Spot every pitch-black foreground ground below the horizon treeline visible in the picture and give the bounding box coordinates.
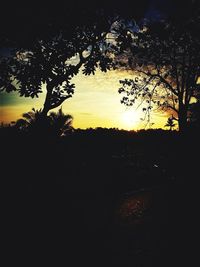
[1,129,199,267]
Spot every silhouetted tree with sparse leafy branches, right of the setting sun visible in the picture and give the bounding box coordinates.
[118,12,200,132]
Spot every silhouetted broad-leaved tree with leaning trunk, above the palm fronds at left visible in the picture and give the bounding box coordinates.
[0,17,112,116]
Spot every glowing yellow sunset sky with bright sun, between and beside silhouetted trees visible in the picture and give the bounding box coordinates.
[0,68,167,130]
